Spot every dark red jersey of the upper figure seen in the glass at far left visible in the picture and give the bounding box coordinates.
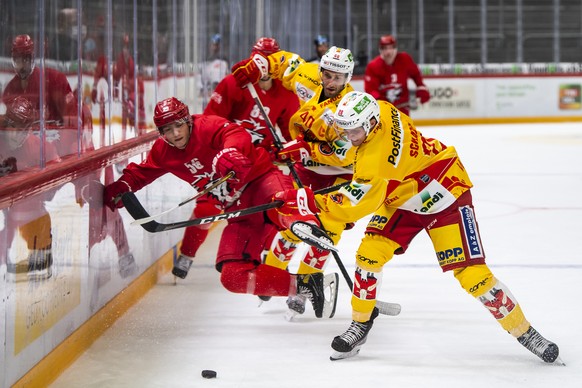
[2,67,77,122]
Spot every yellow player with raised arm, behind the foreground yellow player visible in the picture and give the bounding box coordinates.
[233,46,355,318]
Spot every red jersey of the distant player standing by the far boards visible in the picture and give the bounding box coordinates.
[364,52,424,110]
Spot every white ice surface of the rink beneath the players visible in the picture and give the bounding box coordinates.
[52,123,582,388]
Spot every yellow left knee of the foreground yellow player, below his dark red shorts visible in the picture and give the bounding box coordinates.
[356,234,400,272]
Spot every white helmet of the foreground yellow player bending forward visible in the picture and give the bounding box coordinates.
[334,91,380,136]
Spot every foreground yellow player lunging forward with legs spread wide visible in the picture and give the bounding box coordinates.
[282,92,559,363]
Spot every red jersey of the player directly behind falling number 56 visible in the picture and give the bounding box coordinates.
[204,74,299,152]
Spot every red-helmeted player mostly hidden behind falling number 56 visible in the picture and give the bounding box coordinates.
[172,38,299,279]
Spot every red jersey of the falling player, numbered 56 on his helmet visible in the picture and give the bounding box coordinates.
[119,115,276,201]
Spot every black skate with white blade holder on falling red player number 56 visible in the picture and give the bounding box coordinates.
[296,273,339,318]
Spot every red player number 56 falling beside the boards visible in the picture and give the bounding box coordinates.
[103,97,338,318]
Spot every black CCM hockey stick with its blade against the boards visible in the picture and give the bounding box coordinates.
[121,183,345,233]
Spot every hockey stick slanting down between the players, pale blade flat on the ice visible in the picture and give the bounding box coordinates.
[247,82,401,315]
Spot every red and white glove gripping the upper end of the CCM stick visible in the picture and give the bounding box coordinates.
[267,187,319,229]
